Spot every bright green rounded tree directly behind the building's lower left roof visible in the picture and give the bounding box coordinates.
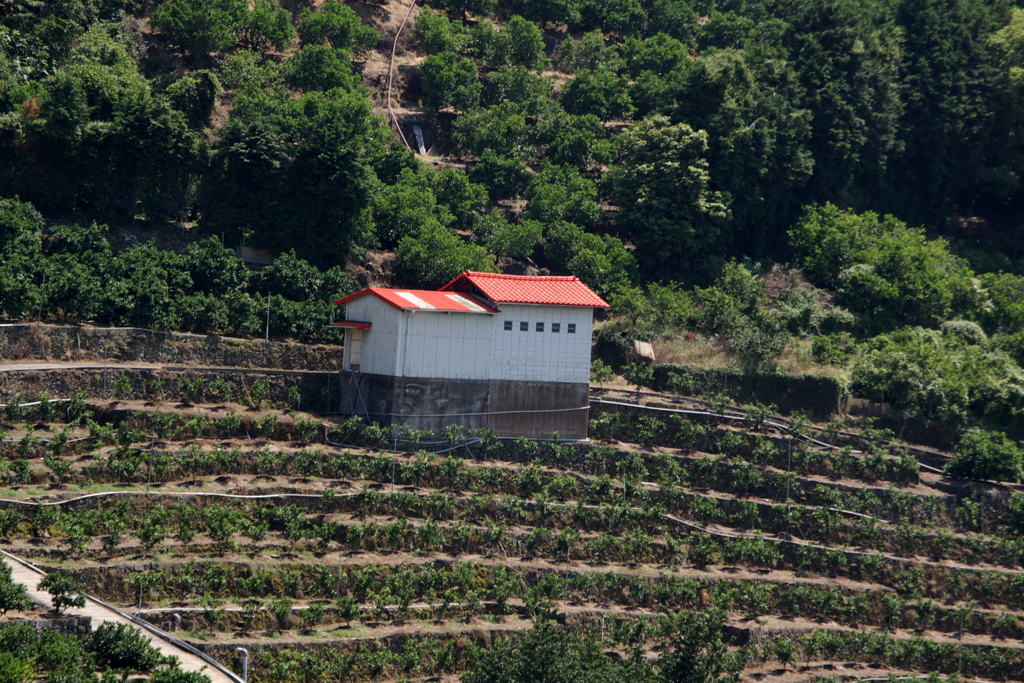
[396,222,497,289]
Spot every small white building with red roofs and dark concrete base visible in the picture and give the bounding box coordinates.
[335,271,608,439]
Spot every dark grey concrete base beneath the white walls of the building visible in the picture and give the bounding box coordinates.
[340,371,590,439]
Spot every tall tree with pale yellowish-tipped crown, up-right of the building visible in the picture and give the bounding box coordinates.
[608,117,728,282]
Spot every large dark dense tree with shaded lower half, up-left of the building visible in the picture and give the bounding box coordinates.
[201,89,378,264]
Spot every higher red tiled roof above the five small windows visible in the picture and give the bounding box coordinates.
[441,270,608,308]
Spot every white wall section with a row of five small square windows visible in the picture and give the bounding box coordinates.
[490,303,594,383]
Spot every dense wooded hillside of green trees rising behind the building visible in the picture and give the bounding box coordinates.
[6,0,1024,444]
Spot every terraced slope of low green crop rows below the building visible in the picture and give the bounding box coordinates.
[0,385,1024,683]
